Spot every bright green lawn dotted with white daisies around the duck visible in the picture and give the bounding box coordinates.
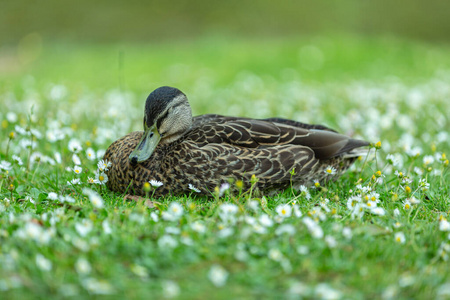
[0,37,450,299]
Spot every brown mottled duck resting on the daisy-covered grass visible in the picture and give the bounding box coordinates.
[104,86,369,197]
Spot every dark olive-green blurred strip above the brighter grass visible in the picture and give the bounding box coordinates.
[0,0,450,44]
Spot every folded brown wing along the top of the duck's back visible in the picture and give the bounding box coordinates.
[188,115,369,159]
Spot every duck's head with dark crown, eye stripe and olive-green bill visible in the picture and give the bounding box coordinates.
[129,86,192,165]
